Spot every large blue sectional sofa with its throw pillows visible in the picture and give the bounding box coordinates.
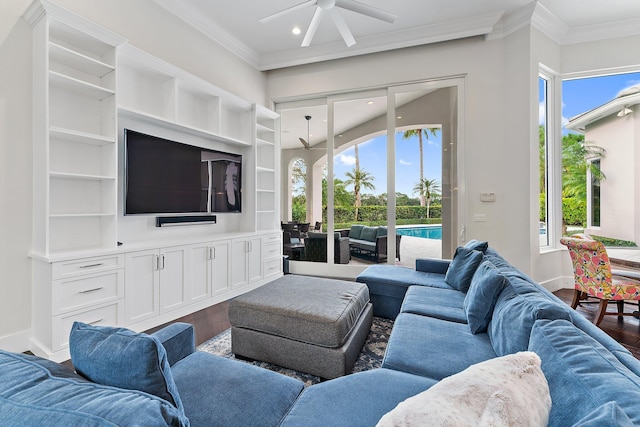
[0,241,640,427]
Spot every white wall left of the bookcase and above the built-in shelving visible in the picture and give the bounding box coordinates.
[0,0,267,351]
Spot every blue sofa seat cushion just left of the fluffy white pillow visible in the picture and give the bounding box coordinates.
[280,368,436,427]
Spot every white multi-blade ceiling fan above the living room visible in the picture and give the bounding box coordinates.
[260,0,397,47]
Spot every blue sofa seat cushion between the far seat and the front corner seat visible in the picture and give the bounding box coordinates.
[382,313,496,380]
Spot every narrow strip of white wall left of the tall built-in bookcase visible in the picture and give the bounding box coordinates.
[0,15,32,350]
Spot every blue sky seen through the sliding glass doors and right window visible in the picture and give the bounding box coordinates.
[334,73,640,201]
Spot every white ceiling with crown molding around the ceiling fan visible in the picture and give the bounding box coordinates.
[155,0,640,70]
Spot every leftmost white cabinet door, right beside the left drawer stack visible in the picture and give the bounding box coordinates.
[124,250,160,324]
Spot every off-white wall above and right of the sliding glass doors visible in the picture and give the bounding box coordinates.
[268,30,537,271]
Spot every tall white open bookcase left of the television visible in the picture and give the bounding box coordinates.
[25,2,124,256]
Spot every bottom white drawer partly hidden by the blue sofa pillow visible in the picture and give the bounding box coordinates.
[52,301,124,351]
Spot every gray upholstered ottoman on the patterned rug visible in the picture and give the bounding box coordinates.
[229,275,373,379]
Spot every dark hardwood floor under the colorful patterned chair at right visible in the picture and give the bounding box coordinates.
[554,289,640,359]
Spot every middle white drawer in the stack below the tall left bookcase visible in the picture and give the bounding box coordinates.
[51,269,124,316]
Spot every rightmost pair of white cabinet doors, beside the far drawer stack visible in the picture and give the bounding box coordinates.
[231,236,262,289]
